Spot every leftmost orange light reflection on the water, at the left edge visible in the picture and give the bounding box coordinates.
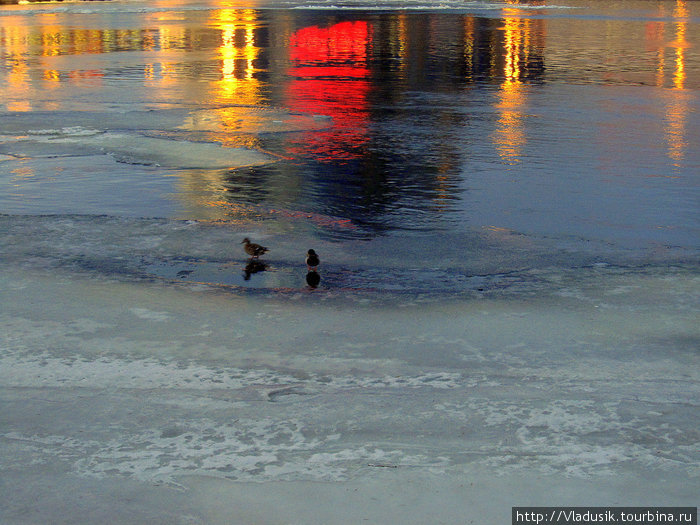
[0,21,32,111]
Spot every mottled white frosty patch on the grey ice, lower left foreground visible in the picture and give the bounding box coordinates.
[0,424,448,483]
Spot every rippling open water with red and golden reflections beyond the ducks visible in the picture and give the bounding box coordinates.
[0,0,700,286]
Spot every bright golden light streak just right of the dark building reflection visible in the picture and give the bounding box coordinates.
[493,18,529,164]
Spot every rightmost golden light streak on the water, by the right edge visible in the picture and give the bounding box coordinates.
[666,0,688,168]
